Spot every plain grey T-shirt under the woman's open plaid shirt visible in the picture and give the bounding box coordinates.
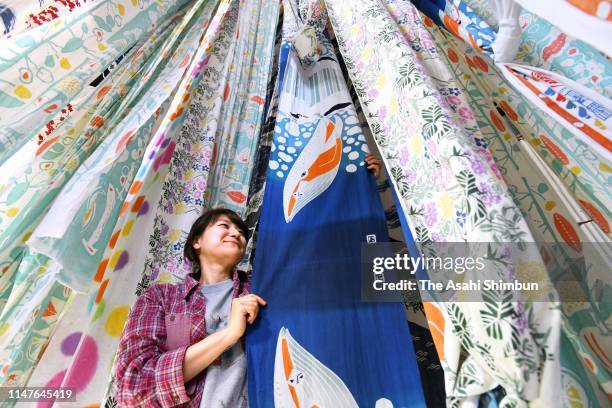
[200,279,249,408]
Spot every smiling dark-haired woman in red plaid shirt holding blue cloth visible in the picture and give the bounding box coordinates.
[116,209,266,407]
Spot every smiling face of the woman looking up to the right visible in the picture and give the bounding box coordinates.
[193,215,246,265]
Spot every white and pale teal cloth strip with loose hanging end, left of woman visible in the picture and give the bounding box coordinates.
[3,7,208,388]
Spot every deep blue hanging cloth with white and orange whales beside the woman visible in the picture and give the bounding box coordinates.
[246,2,425,407]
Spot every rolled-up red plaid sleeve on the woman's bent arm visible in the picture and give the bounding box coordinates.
[115,285,190,407]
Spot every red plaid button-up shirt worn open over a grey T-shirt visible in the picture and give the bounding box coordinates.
[115,271,250,408]
